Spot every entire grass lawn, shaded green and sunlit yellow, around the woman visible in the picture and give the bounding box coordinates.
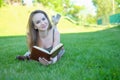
[0,7,120,80]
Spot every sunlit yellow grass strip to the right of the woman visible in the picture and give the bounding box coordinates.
[58,17,111,33]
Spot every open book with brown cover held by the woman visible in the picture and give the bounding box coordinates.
[30,43,63,61]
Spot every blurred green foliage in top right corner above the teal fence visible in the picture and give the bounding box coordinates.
[93,0,120,17]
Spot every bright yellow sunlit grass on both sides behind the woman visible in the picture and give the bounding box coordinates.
[0,5,114,36]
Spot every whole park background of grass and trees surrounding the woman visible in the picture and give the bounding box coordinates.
[0,0,120,80]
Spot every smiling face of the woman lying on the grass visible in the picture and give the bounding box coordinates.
[32,13,49,31]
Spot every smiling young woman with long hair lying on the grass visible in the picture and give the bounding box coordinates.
[16,10,64,65]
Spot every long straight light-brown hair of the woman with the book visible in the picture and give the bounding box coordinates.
[27,10,52,51]
